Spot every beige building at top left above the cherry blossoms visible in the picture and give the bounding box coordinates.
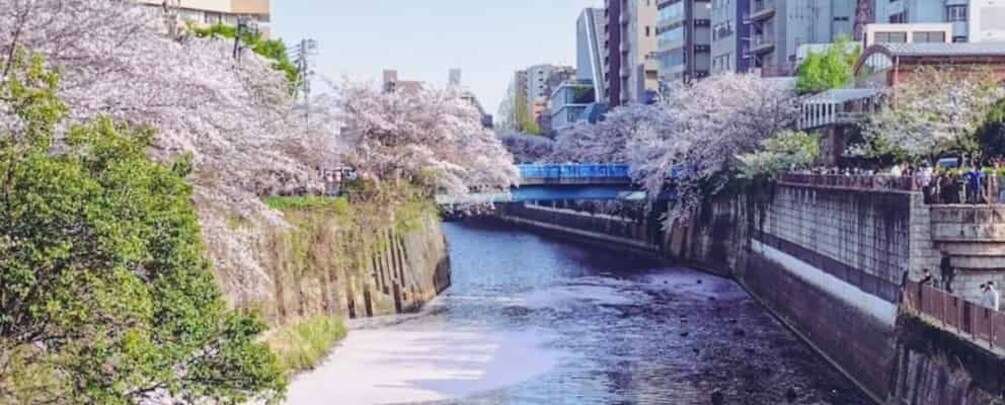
[137,0,270,37]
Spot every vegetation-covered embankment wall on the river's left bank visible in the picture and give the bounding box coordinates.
[239,207,450,325]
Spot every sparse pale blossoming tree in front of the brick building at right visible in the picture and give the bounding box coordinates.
[849,67,1005,160]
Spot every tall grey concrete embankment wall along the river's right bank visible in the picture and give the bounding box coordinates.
[492,185,956,402]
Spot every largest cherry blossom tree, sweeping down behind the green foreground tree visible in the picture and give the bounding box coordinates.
[0,0,333,298]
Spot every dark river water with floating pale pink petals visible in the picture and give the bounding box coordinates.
[287,223,869,405]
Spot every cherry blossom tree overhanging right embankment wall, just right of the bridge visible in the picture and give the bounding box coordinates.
[627,74,798,219]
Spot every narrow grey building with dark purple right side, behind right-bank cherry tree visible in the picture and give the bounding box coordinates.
[709,0,750,74]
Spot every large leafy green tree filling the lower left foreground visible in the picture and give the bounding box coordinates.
[0,51,286,404]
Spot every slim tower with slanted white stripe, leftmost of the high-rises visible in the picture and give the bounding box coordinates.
[576,8,606,97]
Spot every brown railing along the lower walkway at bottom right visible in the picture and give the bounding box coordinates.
[903,281,1005,352]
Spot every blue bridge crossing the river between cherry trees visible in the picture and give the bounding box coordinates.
[436,164,646,205]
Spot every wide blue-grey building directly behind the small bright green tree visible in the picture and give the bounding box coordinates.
[746,0,856,75]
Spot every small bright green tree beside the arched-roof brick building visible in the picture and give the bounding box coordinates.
[796,36,861,94]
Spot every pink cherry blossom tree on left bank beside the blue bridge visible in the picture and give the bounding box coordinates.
[337,82,519,195]
